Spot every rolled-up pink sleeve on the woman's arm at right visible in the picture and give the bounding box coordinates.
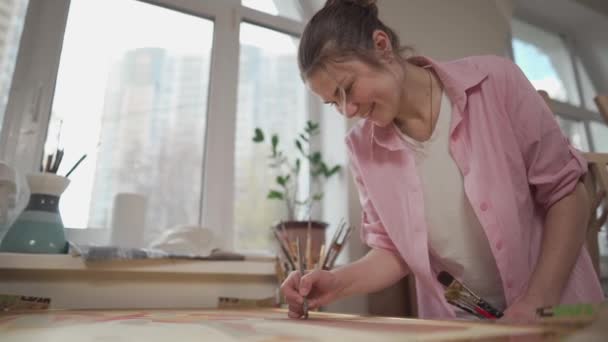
[505,61,587,210]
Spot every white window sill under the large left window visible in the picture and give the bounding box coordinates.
[0,253,275,276]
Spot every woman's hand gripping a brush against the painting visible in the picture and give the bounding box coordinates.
[281,270,342,318]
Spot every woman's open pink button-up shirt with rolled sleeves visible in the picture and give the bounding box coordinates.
[346,56,603,318]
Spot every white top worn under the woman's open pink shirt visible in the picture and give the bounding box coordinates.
[395,93,505,317]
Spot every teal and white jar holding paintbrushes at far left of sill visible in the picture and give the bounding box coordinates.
[0,173,70,254]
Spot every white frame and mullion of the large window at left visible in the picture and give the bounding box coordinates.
[0,0,320,249]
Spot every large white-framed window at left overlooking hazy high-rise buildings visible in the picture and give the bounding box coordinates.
[0,0,328,250]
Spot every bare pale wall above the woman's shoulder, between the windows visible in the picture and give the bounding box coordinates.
[378,0,512,60]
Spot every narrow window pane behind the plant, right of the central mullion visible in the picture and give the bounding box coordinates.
[234,23,307,250]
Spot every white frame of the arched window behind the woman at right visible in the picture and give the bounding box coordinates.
[510,14,605,152]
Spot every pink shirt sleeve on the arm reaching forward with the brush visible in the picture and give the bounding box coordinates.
[346,139,398,253]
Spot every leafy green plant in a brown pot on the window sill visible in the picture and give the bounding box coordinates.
[253,120,341,266]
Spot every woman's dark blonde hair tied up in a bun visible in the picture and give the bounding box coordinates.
[298,0,411,79]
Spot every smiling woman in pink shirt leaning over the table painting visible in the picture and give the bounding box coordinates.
[281,0,602,321]
